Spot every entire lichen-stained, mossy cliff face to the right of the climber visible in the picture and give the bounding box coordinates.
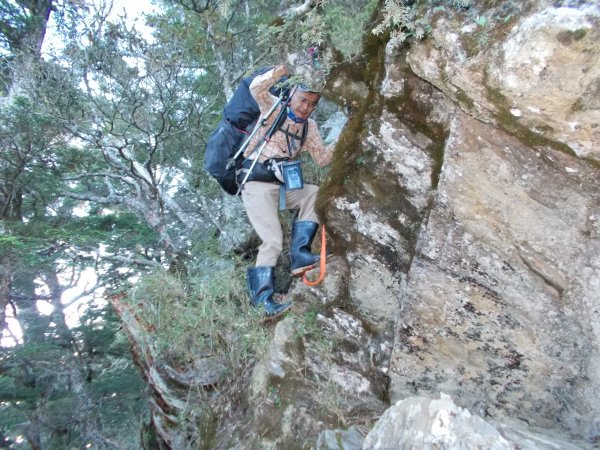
[243,1,600,449]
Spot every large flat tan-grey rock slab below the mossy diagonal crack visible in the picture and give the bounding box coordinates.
[391,115,600,437]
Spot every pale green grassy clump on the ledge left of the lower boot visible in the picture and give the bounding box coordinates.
[131,266,266,372]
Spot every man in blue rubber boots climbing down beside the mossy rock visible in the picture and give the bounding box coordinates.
[238,65,335,318]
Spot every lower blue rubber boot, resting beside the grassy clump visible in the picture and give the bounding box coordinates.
[247,266,292,319]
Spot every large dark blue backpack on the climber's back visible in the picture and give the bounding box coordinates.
[204,67,305,195]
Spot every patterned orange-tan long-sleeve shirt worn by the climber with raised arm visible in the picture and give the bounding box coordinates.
[244,66,335,167]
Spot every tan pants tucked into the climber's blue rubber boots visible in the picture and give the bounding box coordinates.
[242,181,319,267]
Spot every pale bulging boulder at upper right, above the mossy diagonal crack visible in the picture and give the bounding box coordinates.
[408,1,600,161]
